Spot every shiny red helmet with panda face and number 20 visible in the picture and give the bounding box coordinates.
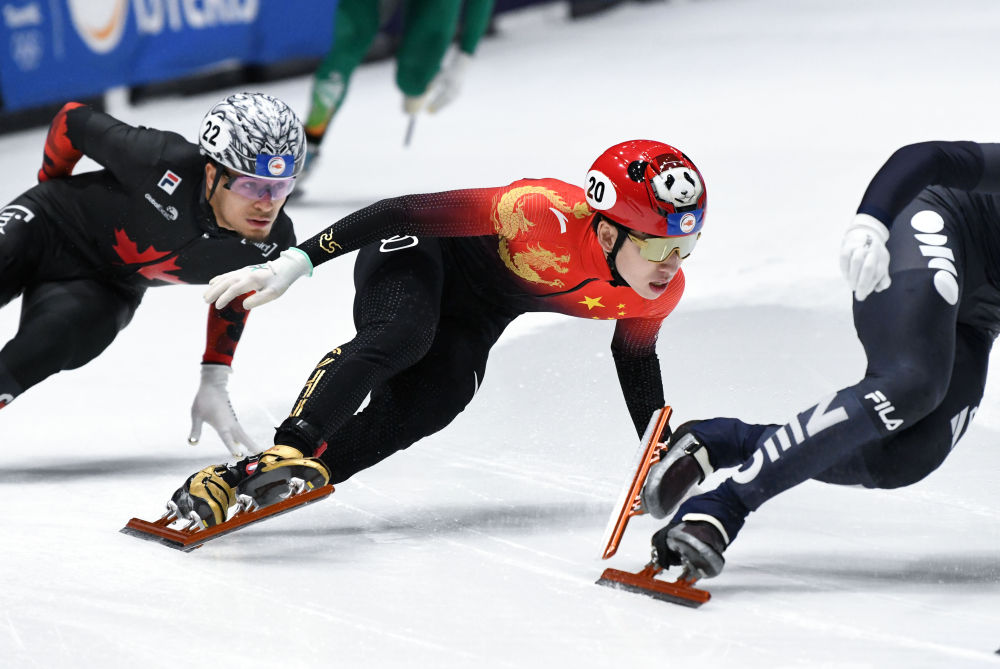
[586,139,708,237]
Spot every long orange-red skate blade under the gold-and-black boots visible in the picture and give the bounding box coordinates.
[121,485,333,553]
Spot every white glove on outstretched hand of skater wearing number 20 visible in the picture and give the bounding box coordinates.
[205,246,312,309]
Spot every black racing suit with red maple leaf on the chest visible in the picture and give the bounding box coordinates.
[0,104,295,406]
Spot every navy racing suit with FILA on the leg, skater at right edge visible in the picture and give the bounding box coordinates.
[700,142,1000,516]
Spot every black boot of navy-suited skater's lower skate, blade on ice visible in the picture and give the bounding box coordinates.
[653,481,750,578]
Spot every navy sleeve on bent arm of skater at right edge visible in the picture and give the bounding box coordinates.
[858,141,1000,227]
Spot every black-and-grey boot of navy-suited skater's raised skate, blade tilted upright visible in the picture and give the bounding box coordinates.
[642,421,715,518]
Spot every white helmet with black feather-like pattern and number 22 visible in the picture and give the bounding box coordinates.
[198,93,306,179]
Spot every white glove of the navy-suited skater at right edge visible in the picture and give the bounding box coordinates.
[840,214,891,302]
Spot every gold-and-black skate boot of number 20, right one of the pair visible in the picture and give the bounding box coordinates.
[236,445,330,508]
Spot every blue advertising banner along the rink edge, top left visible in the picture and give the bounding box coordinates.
[0,0,337,111]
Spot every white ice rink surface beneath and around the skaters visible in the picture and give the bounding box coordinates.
[0,0,1000,669]
